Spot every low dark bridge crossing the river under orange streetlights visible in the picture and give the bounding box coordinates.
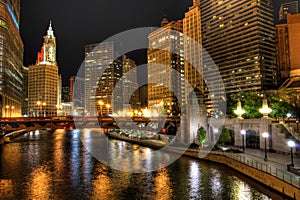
[0,116,180,135]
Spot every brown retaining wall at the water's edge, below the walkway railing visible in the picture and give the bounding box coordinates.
[108,133,300,200]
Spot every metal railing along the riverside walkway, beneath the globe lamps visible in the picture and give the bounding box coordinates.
[210,151,300,188]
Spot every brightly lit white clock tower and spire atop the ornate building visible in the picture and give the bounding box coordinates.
[36,21,57,66]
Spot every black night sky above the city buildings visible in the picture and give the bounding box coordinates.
[20,0,290,84]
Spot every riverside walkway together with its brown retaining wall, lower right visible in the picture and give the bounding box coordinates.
[109,133,300,200]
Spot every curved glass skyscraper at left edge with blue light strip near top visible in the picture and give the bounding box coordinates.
[0,0,24,117]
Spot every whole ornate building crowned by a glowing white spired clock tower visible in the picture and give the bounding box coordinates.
[28,22,60,117]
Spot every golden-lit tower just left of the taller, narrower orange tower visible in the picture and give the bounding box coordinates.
[147,18,185,115]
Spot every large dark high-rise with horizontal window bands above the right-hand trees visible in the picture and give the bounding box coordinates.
[200,0,278,105]
